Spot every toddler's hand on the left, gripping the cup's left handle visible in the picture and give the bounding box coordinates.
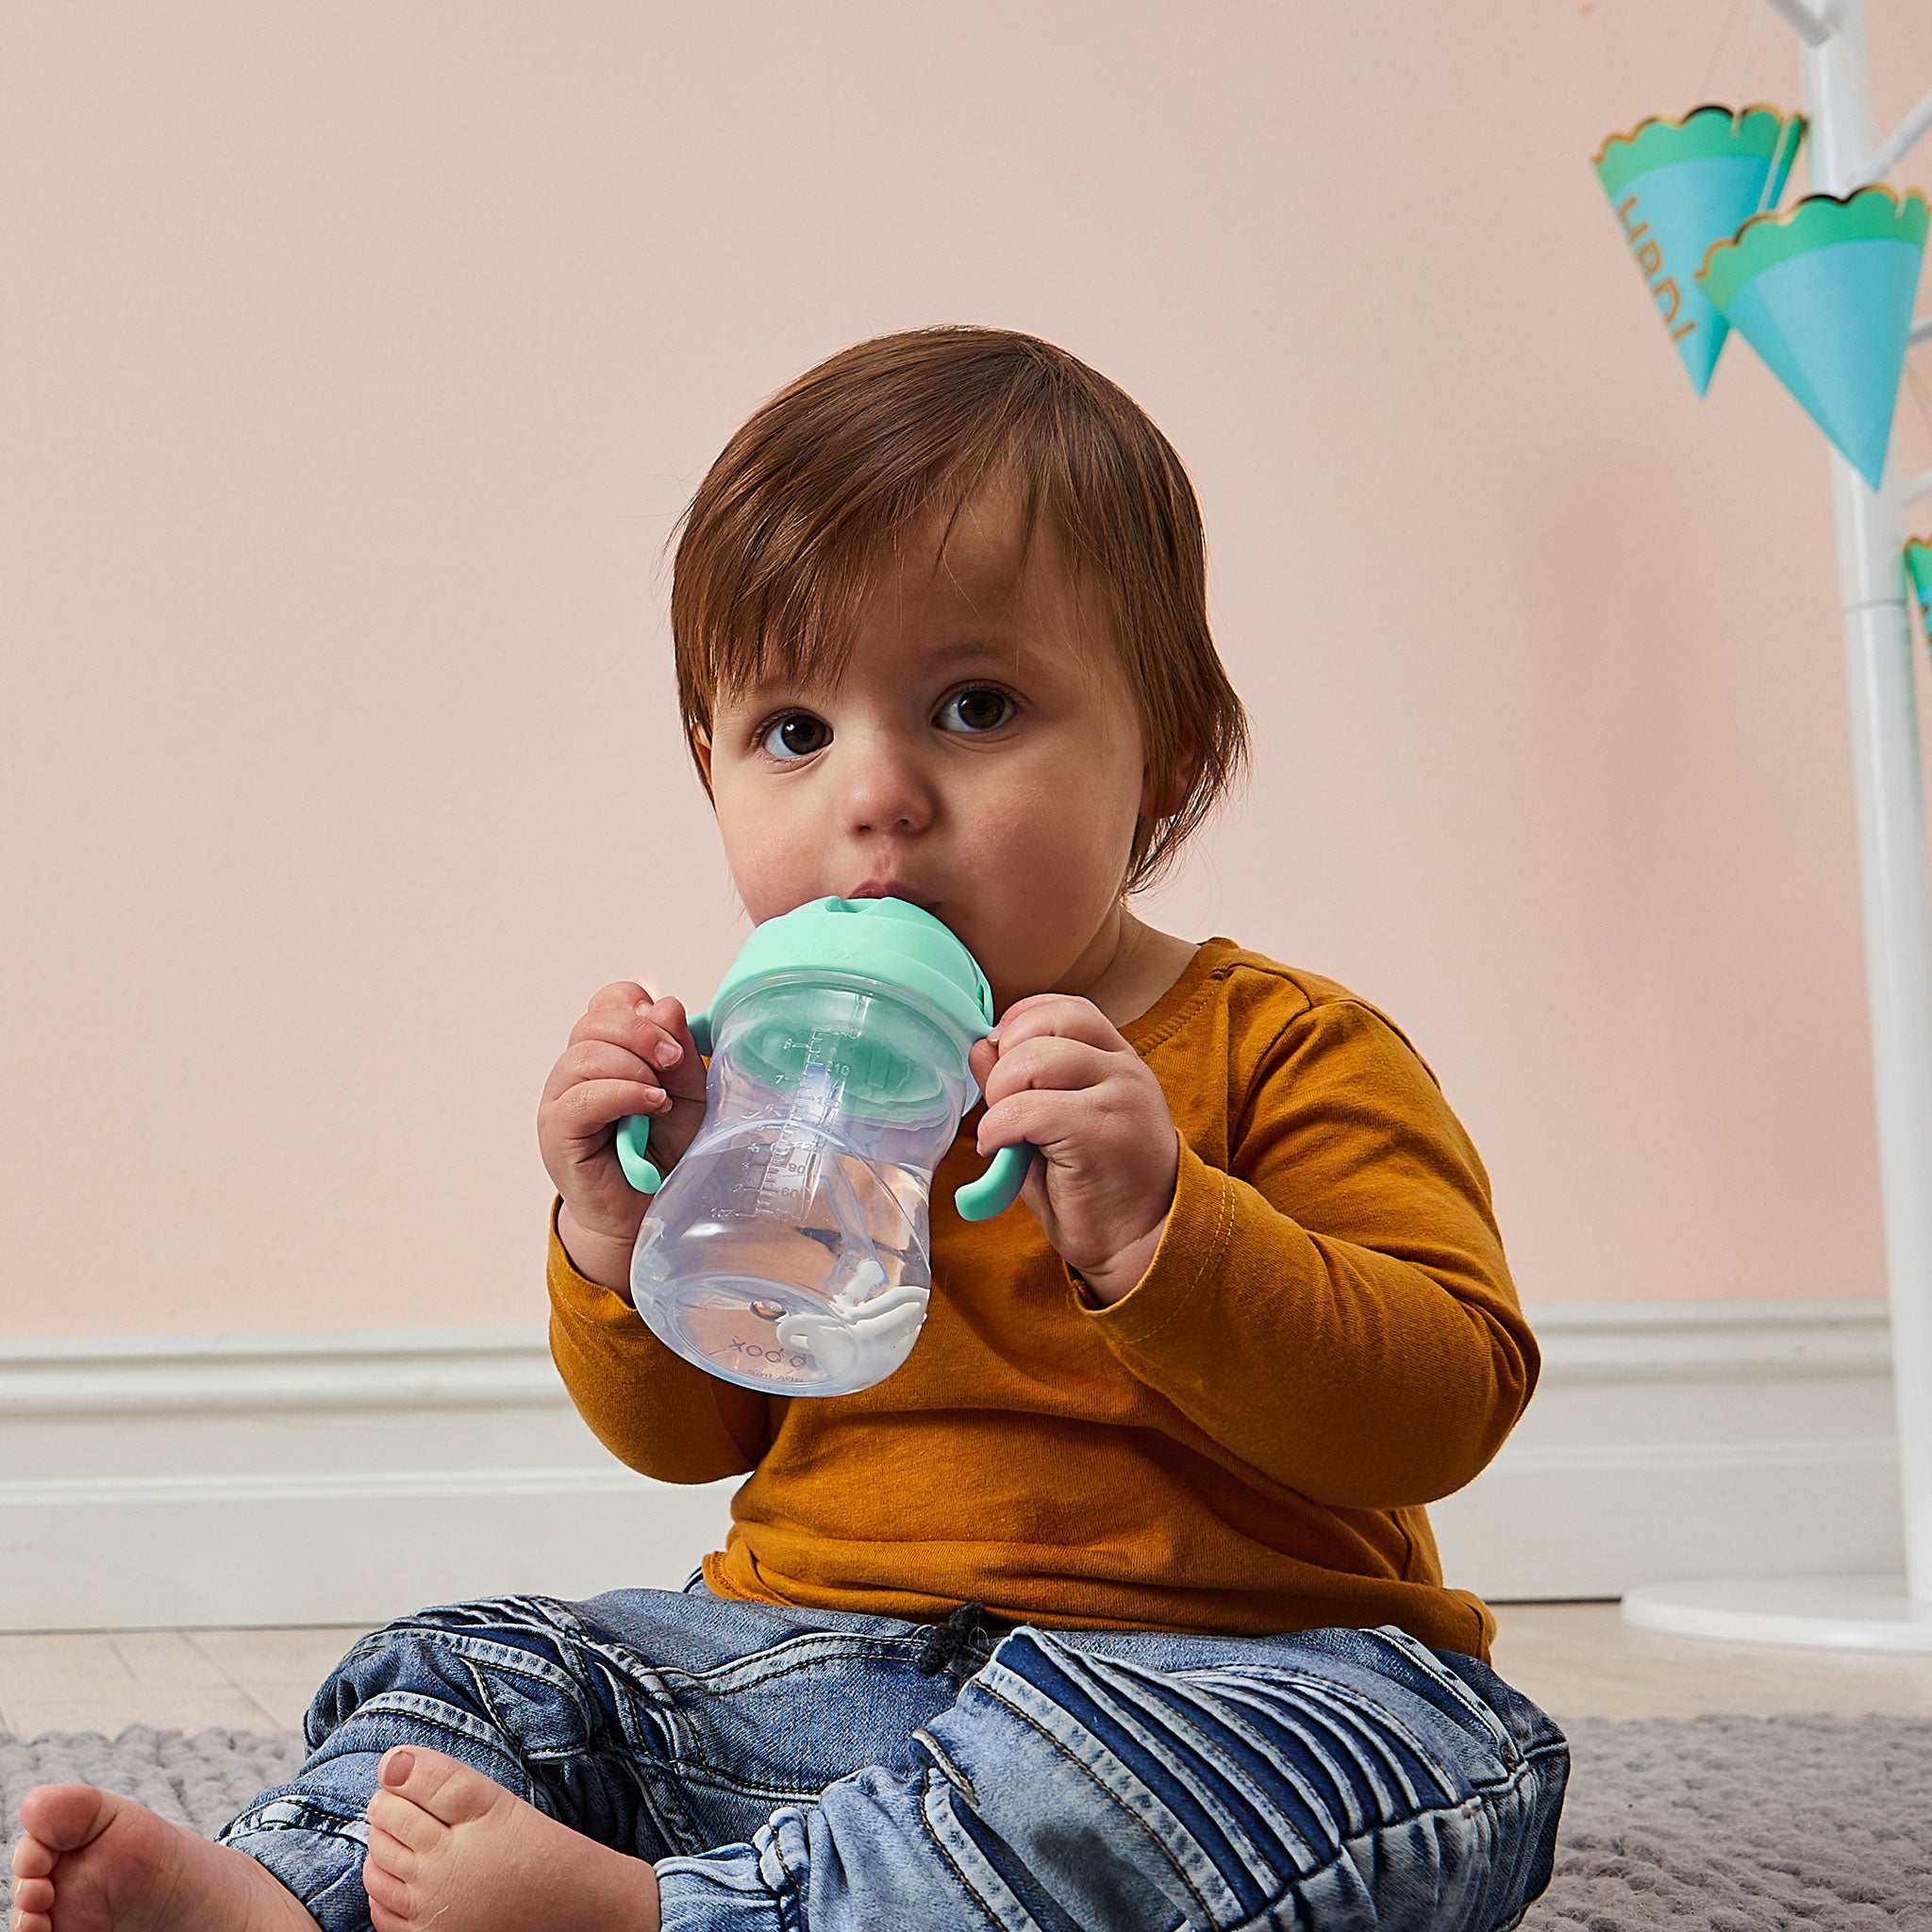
[537,979,706,1287]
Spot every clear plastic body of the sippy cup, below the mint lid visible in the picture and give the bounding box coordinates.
[630,979,977,1395]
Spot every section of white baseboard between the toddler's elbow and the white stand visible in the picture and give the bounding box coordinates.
[1430,1298,1905,1602]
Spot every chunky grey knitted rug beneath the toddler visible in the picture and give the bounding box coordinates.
[0,1718,1932,1932]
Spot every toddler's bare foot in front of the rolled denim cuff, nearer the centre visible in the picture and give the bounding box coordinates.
[360,1744,657,1932]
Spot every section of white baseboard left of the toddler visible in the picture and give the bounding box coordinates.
[0,1327,736,1631]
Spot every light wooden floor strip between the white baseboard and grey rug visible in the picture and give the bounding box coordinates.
[0,1604,1932,1739]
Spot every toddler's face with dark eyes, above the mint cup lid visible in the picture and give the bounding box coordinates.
[699,496,1156,1012]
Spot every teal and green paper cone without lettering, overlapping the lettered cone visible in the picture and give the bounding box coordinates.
[1698,188,1926,489]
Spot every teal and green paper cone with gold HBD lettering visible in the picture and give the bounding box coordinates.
[1592,107,1805,396]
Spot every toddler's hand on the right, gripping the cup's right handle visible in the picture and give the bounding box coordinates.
[972,993,1180,1302]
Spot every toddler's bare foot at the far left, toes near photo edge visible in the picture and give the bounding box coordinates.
[11,1785,317,1932]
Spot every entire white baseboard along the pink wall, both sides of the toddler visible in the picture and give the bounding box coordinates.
[0,1300,1901,1631]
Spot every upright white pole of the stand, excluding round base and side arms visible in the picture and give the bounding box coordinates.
[1801,0,1932,1609]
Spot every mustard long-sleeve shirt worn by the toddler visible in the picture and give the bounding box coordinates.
[549,939,1538,1656]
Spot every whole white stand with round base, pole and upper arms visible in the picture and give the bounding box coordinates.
[1623,0,1932,1650]
